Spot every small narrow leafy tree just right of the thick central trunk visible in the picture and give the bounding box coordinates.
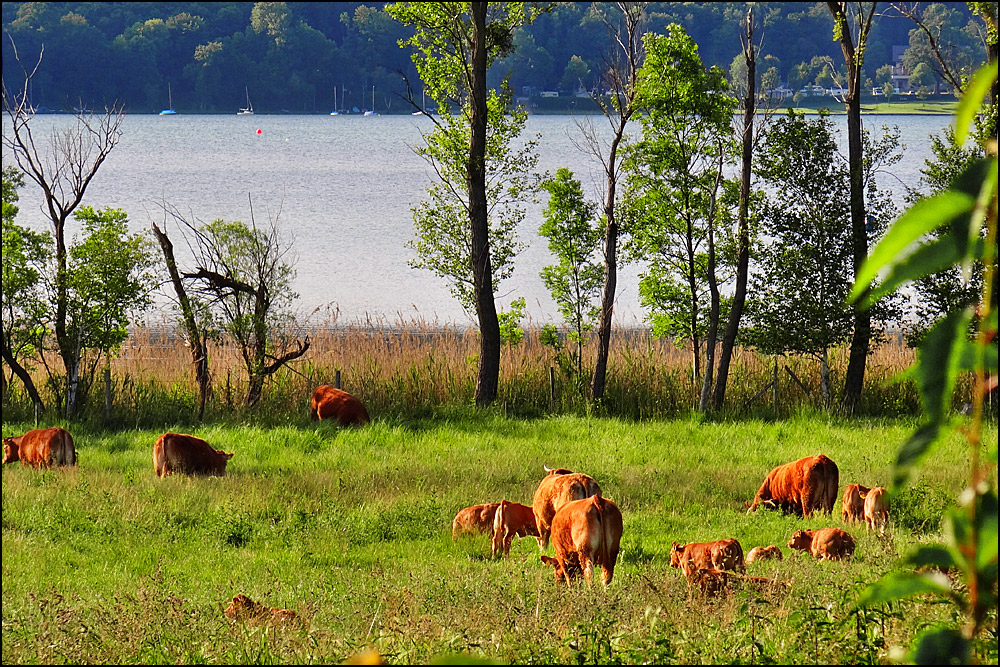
[538,167,604,395]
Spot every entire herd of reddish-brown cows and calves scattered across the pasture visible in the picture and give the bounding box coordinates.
[3,385,889,600]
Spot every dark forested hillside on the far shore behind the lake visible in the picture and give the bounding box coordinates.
[3,2,985,113]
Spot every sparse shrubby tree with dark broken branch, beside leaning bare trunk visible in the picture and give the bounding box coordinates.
[183,220,309,407]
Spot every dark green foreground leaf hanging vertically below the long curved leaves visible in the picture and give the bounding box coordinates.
[917,308,972,424]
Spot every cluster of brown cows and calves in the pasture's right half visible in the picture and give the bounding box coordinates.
[452,454,889,594]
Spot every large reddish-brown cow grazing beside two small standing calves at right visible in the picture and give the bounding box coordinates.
[747,454,840,518]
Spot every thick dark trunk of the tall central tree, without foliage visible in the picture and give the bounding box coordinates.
[468,2,500,407]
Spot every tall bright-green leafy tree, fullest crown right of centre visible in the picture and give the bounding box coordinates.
[627,24,736,404]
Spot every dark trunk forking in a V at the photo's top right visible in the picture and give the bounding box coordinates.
[827,2,878,412]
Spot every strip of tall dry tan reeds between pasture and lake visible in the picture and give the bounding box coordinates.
[4,315,948,426]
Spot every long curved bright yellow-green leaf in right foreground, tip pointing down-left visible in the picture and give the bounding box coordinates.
[849,190,975,302]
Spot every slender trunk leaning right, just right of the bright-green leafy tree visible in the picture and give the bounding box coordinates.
[712,8,757,410]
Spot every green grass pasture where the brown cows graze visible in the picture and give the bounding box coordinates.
[2,411,997,664]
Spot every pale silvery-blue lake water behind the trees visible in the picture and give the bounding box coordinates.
[3,114,951,326]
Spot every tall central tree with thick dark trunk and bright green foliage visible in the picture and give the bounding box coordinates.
[386,2,538,407]
